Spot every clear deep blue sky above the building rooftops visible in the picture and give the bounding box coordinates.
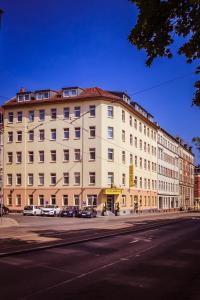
[0,0,200,162]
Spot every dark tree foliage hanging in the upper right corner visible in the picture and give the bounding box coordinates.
[129,0,200,107]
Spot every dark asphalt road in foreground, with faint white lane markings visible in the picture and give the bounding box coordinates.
[0,217,200,300]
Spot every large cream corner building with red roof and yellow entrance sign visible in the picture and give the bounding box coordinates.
[1,87,157,214]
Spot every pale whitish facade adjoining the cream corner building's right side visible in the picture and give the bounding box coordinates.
[157,128,180,210]
